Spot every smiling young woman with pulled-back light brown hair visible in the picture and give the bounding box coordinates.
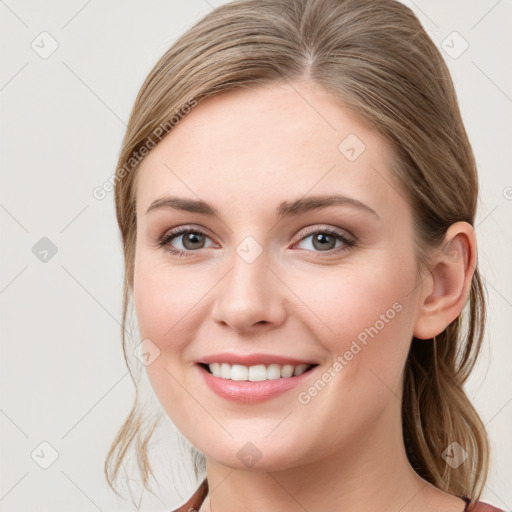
[105,0,504,512]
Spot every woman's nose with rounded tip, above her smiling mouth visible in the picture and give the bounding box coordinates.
[212,243,288,333]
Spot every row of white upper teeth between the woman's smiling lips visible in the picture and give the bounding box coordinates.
[208,363,311,382]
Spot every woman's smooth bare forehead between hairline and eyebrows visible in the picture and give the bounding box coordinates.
[136,82,403,222]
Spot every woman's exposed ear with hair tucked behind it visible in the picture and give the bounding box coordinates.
[413,222,477,340]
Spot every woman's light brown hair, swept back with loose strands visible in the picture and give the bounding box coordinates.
[105,0,489,502]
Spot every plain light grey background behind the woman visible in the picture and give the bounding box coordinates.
[0,0,512,512]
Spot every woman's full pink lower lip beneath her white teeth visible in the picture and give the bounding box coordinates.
[197,365,317,404]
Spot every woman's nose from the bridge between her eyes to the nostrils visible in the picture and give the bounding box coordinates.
[210,236,285,330]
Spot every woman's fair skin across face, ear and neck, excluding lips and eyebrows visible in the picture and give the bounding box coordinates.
[133,81,476,512]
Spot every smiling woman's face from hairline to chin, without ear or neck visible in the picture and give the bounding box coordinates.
[134,82,419,470]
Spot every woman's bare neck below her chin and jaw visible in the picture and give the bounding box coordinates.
[196,404,444,512]
